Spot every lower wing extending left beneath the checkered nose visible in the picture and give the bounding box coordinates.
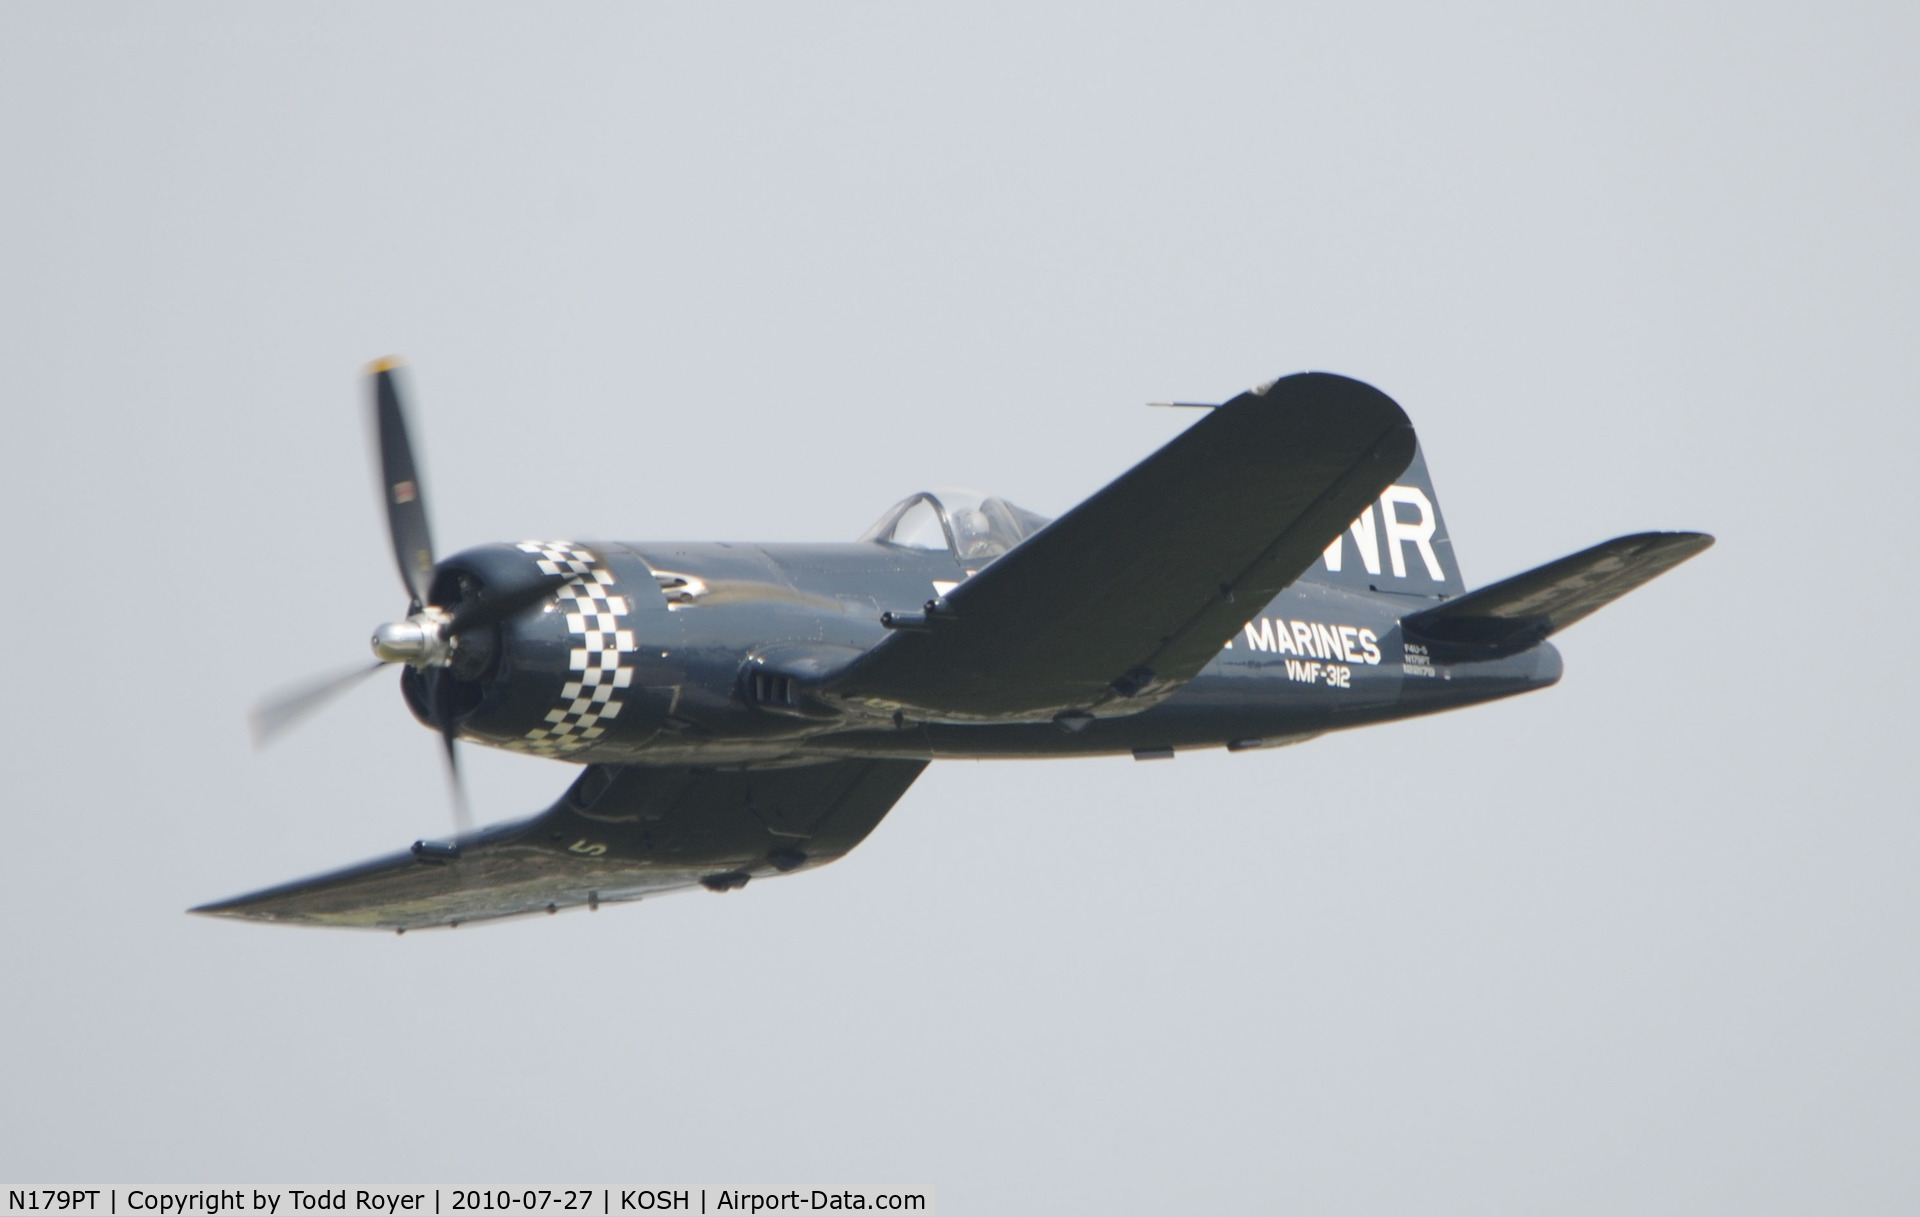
[192,760,925,931]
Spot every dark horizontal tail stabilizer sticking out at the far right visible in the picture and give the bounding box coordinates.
[1400,532,1713,653]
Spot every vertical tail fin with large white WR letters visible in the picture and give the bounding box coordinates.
[1300,447,1467,599]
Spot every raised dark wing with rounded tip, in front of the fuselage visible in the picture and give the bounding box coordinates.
[820,372,1415,722]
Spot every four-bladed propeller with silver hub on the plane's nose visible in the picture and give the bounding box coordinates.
[253,359,576,833]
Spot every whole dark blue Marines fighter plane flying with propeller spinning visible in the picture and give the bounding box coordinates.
[194,361,1713,931]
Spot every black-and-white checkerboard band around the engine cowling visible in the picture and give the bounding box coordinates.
[509,541,634,756]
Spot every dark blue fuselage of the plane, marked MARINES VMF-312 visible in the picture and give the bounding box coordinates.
[420,541,1561,766]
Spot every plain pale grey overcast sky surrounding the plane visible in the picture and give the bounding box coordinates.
[0,2,1920,1215]
